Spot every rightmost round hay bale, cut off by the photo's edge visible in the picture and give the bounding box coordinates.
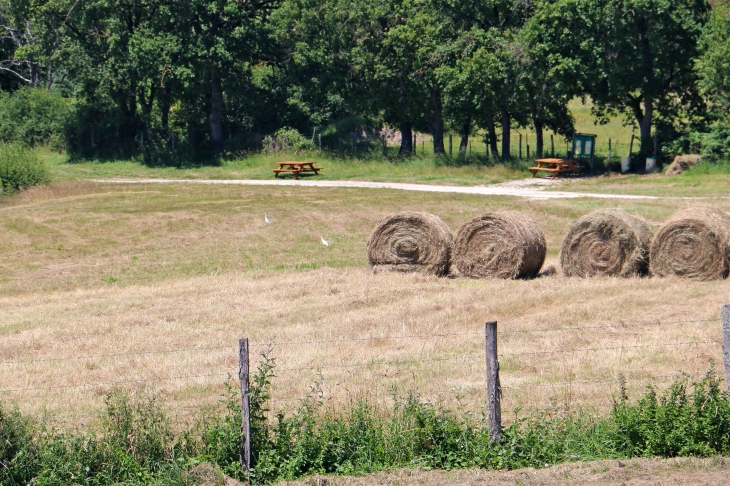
[651,206,730,280]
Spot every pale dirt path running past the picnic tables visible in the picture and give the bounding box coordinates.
[96,179,658,199]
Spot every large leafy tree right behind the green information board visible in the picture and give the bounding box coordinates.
[540,0,709,170]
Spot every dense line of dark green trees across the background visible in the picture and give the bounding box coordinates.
[0,0,730,167]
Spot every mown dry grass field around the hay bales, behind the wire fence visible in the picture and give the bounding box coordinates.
[0,181,730,425]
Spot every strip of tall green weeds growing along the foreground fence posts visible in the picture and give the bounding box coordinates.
[0,358,730,485]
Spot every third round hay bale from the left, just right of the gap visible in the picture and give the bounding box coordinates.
[560,209,651,277]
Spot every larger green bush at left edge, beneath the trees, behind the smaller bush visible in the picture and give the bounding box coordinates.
[0,87,72,150]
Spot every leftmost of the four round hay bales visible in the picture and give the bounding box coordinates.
[367,211,454,276]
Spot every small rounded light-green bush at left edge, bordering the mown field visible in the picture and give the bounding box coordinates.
[0,145,50,193]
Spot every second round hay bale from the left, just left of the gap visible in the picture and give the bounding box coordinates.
[454,211,546,278]
